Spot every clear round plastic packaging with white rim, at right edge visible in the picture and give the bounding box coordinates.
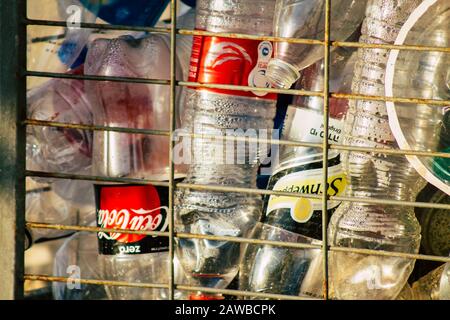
[385,0,450,195]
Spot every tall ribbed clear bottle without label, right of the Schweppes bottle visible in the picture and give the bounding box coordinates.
[328,0,423,299]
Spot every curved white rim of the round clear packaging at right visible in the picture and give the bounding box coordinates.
[385,0,450,195]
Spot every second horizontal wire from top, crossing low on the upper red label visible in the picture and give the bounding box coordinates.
[23,70,450,106]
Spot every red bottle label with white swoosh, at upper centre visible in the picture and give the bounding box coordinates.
[189,36,277,100]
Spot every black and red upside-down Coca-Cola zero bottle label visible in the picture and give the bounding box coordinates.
[95,185,169,255]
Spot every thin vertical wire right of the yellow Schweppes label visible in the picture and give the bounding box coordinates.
[322,0,330,300]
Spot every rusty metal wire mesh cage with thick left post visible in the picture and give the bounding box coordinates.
[0,0,450,299]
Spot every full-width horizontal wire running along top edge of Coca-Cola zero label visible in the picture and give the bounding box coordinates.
[25,170,450,210]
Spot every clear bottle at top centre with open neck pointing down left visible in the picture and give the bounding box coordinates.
[267,0,367,89]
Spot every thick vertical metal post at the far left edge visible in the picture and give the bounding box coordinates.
[0,0,26,300]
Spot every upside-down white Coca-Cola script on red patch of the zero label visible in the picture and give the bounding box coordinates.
[97,185,168,243]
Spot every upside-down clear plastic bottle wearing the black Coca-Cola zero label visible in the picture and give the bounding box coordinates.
[85,34,180,299]
